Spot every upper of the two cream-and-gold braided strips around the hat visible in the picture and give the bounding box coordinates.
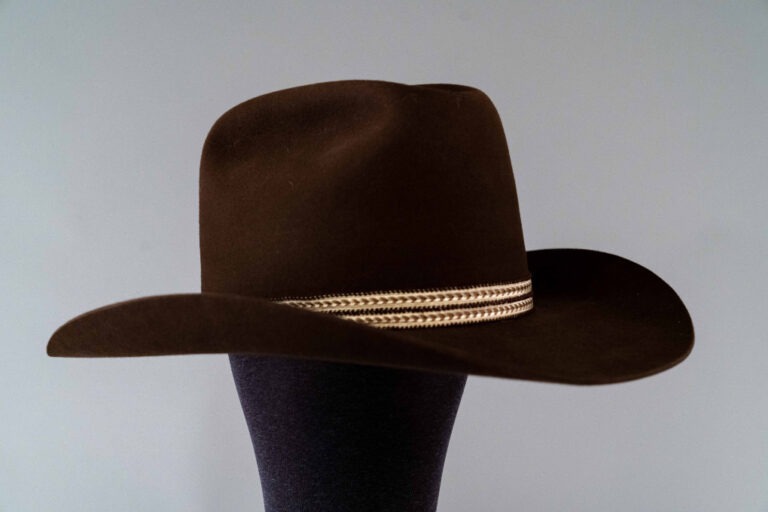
[276,279,532,313]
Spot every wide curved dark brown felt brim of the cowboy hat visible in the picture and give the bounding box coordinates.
[48,249,694,384]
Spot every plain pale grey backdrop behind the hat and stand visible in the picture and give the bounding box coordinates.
[0,0,768,512]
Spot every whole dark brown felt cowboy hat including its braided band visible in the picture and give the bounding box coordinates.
[48,80,693,384]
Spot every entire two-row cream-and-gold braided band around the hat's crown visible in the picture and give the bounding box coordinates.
[276,279,533,329]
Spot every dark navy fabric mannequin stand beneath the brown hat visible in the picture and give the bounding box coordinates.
[230,354,467,512]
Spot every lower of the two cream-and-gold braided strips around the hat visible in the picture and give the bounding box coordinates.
[339,297,533,329]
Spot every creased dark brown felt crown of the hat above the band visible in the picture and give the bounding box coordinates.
[200,80,528,298]
